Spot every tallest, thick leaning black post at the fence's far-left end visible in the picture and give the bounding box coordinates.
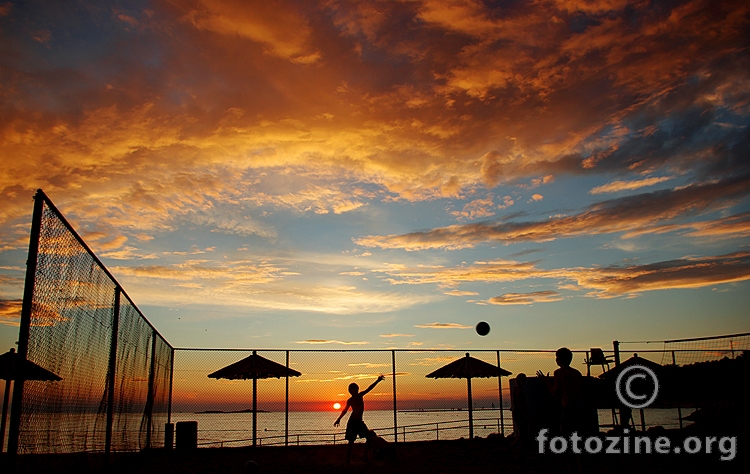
[8,189,45,456]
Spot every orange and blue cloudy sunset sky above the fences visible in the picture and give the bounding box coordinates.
[0,0,750,358]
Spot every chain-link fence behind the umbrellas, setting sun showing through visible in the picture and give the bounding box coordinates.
[172,348,609,447]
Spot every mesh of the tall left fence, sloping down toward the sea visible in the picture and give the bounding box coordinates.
[18,197,172,454]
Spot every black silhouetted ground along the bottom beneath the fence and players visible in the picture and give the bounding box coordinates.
[7,439,750,474]
